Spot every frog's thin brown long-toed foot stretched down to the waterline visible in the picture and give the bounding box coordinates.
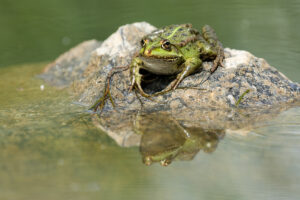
[89,66,129,112]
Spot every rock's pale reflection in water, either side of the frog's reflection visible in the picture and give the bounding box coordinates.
[89,101,299,147]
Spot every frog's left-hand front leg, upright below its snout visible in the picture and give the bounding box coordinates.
[130,57,150,97]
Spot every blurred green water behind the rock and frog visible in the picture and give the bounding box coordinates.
[0,0,300,81]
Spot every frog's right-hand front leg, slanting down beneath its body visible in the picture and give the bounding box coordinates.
[155,57,202,95]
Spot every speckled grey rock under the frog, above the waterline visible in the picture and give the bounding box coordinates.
[71,24,300,112]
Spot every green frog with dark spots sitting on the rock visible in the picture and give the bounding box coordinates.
[130,24,224,97]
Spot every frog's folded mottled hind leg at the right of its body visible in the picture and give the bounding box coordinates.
[202,25,224,73]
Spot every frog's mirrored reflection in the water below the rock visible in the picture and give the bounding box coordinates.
[136,113,224,166]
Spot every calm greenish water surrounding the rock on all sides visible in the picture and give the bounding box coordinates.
[0,0,300,200]
